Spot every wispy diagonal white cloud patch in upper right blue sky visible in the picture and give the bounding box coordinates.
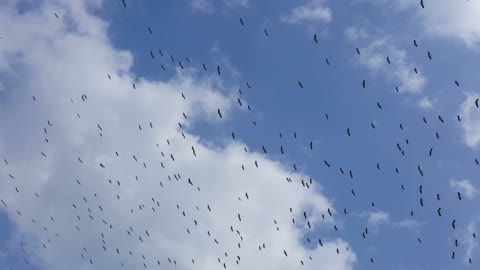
[345,26,427,94]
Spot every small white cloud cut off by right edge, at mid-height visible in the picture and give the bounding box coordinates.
[458,93,480,149]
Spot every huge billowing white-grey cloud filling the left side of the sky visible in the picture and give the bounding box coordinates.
[0,0,356,270]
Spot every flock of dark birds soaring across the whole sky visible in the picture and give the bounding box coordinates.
[0,0,480,269]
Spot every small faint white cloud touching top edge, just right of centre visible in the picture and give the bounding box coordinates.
[280,0,332,23]
